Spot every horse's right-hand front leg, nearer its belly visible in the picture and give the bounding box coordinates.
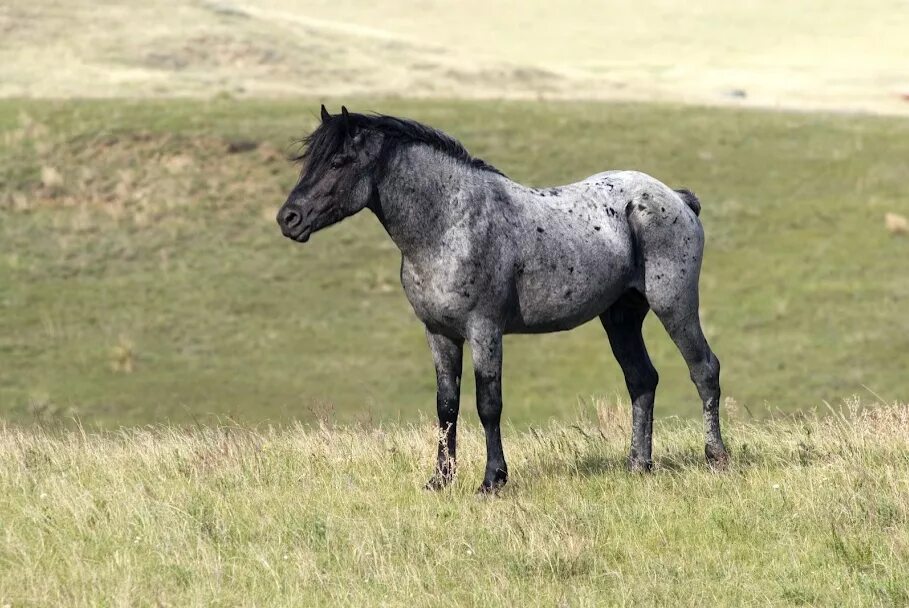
[470,325,508,494]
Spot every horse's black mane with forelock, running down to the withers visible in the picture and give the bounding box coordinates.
[292,112,504,178]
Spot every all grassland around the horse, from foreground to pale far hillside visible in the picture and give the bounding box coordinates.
[0,5,909,608]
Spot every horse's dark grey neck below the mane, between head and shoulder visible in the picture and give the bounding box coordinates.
[374,146,490,259]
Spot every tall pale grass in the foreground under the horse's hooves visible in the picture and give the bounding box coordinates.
[0,402,909,606]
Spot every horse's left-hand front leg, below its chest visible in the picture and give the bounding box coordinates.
[426,329,464,490]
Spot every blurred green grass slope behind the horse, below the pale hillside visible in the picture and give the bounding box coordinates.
[0,99,909,427]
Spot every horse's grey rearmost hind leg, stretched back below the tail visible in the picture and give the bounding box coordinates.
[647,282,729,469]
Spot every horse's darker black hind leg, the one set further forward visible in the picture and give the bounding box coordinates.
[600,291,659,471]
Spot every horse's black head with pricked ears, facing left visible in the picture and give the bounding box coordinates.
[277,105,383,243]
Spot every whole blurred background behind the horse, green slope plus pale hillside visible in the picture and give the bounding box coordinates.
[0,0,909,427]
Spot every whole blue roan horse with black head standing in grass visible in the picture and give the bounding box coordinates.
[278,106,728,492]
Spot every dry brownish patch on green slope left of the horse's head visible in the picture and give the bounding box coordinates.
[0,124,290,225]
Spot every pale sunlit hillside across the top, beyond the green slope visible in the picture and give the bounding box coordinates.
[0,0,909,115]
